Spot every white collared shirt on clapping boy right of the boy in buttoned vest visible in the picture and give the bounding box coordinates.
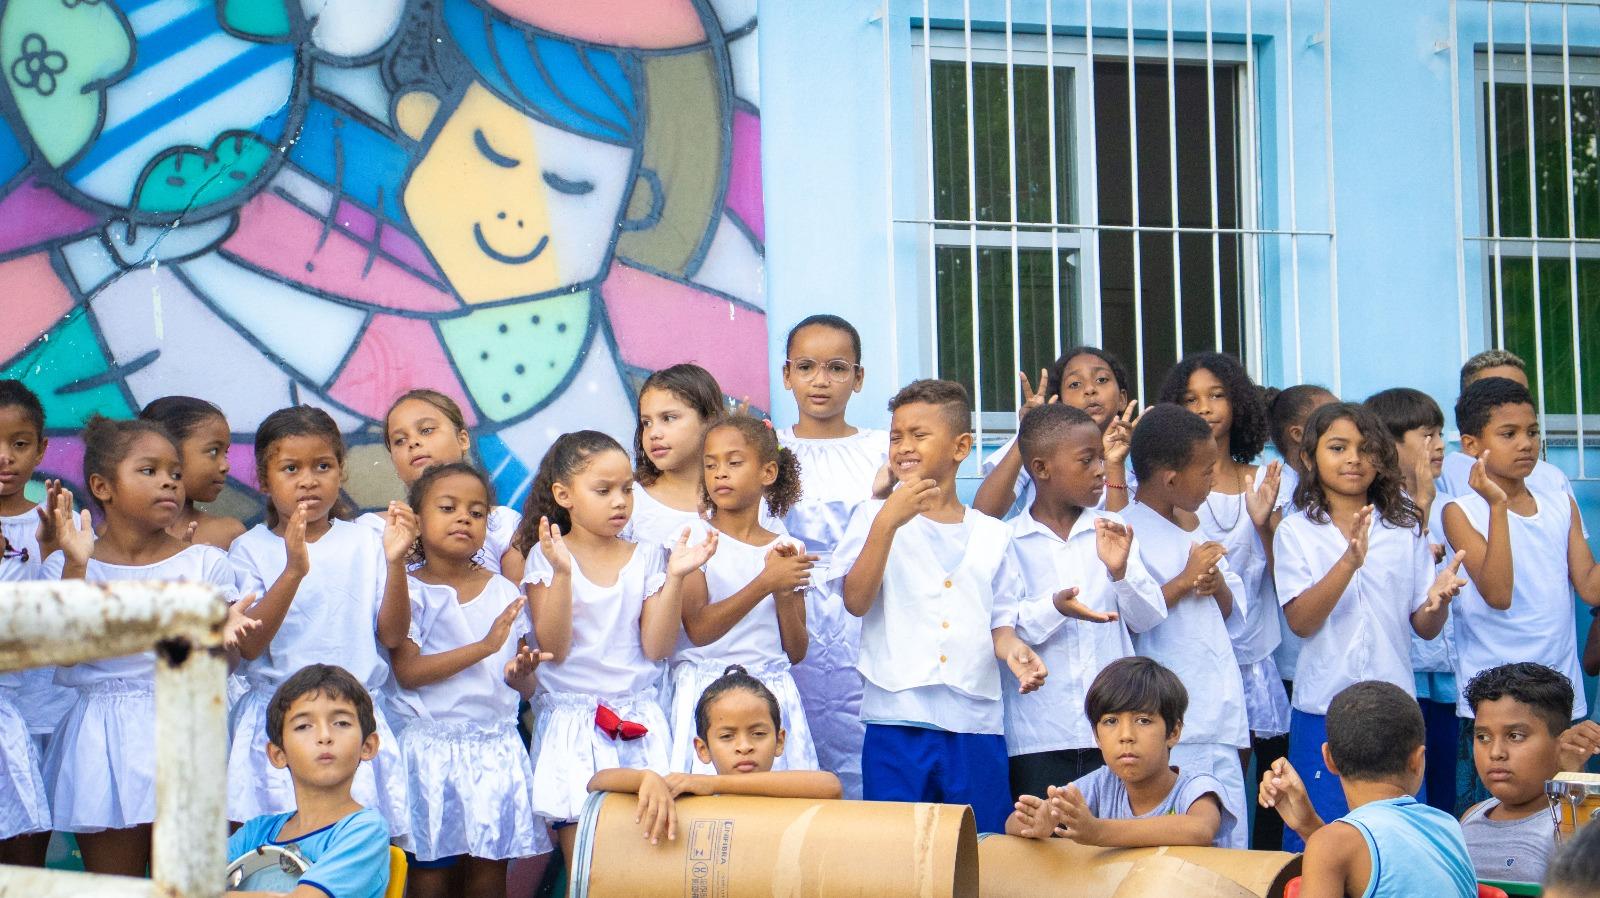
[1005,509,1166,756]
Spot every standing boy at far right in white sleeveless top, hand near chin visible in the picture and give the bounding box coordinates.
[1443,378,1600,720]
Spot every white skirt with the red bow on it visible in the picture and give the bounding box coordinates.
[530,690,672,823]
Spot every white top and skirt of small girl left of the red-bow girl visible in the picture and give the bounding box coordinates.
[400,576,550,861]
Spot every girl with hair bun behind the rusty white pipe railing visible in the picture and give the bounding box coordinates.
[43,416,235,876]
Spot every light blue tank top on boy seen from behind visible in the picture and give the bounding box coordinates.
[1339,796,1478,898]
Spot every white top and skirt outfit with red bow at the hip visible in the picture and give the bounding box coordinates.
[523,544,672,823]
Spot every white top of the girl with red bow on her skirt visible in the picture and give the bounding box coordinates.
[522,534,667,698]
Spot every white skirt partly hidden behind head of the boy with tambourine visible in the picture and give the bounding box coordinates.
[227,687,411,848]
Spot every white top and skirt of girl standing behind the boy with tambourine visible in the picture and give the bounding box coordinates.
[227,520,411,845]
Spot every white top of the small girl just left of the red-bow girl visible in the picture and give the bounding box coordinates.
[406,575,533,725]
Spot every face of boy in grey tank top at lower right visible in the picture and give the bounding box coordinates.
[1472,696,1560,805]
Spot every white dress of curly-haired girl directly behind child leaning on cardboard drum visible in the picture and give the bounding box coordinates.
[672,535,818,773]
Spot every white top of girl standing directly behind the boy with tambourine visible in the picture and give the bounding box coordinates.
[229,519,389,693]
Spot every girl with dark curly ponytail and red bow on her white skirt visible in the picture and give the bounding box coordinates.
[515,431,717,863]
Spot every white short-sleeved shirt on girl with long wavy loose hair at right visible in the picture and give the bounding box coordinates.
[1272,511,1434,714]
